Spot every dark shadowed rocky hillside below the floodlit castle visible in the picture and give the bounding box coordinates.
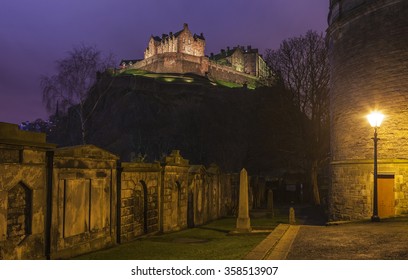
[55,76,303,173]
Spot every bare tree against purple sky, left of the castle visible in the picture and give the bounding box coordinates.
[40,45,113,144]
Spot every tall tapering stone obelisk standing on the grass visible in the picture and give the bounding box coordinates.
[237,168,252,232]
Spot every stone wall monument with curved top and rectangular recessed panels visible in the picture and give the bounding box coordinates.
[50,145,118,259]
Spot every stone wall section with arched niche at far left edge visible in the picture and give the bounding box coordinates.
[0,123,55,260]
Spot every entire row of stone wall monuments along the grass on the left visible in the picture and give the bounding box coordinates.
[0,123,242,259]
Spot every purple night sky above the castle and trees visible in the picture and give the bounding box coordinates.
[0,0,329,123]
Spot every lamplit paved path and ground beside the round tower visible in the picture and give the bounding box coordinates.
[246,206,408,260]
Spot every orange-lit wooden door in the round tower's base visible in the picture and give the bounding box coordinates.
[377,174,395,218]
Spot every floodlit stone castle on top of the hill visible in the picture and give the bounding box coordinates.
[120,23,271,86]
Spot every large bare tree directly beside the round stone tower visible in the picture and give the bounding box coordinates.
[266,31,329,205]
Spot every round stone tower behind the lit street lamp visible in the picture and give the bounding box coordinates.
[327,0,408,220]
